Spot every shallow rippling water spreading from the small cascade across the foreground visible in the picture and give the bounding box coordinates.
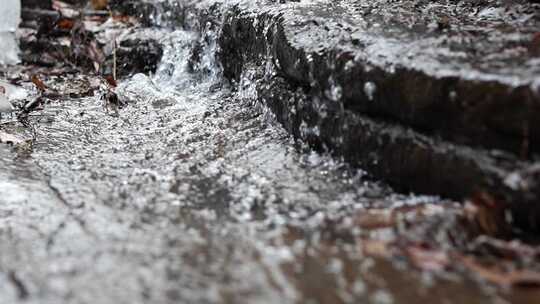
[0,25,536,304]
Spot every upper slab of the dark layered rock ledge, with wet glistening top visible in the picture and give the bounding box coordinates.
[223,1,540,156]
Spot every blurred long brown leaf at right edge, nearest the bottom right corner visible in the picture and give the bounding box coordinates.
[460,256,540,288]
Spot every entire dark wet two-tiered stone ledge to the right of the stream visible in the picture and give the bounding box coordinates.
[156,0,540,232]
